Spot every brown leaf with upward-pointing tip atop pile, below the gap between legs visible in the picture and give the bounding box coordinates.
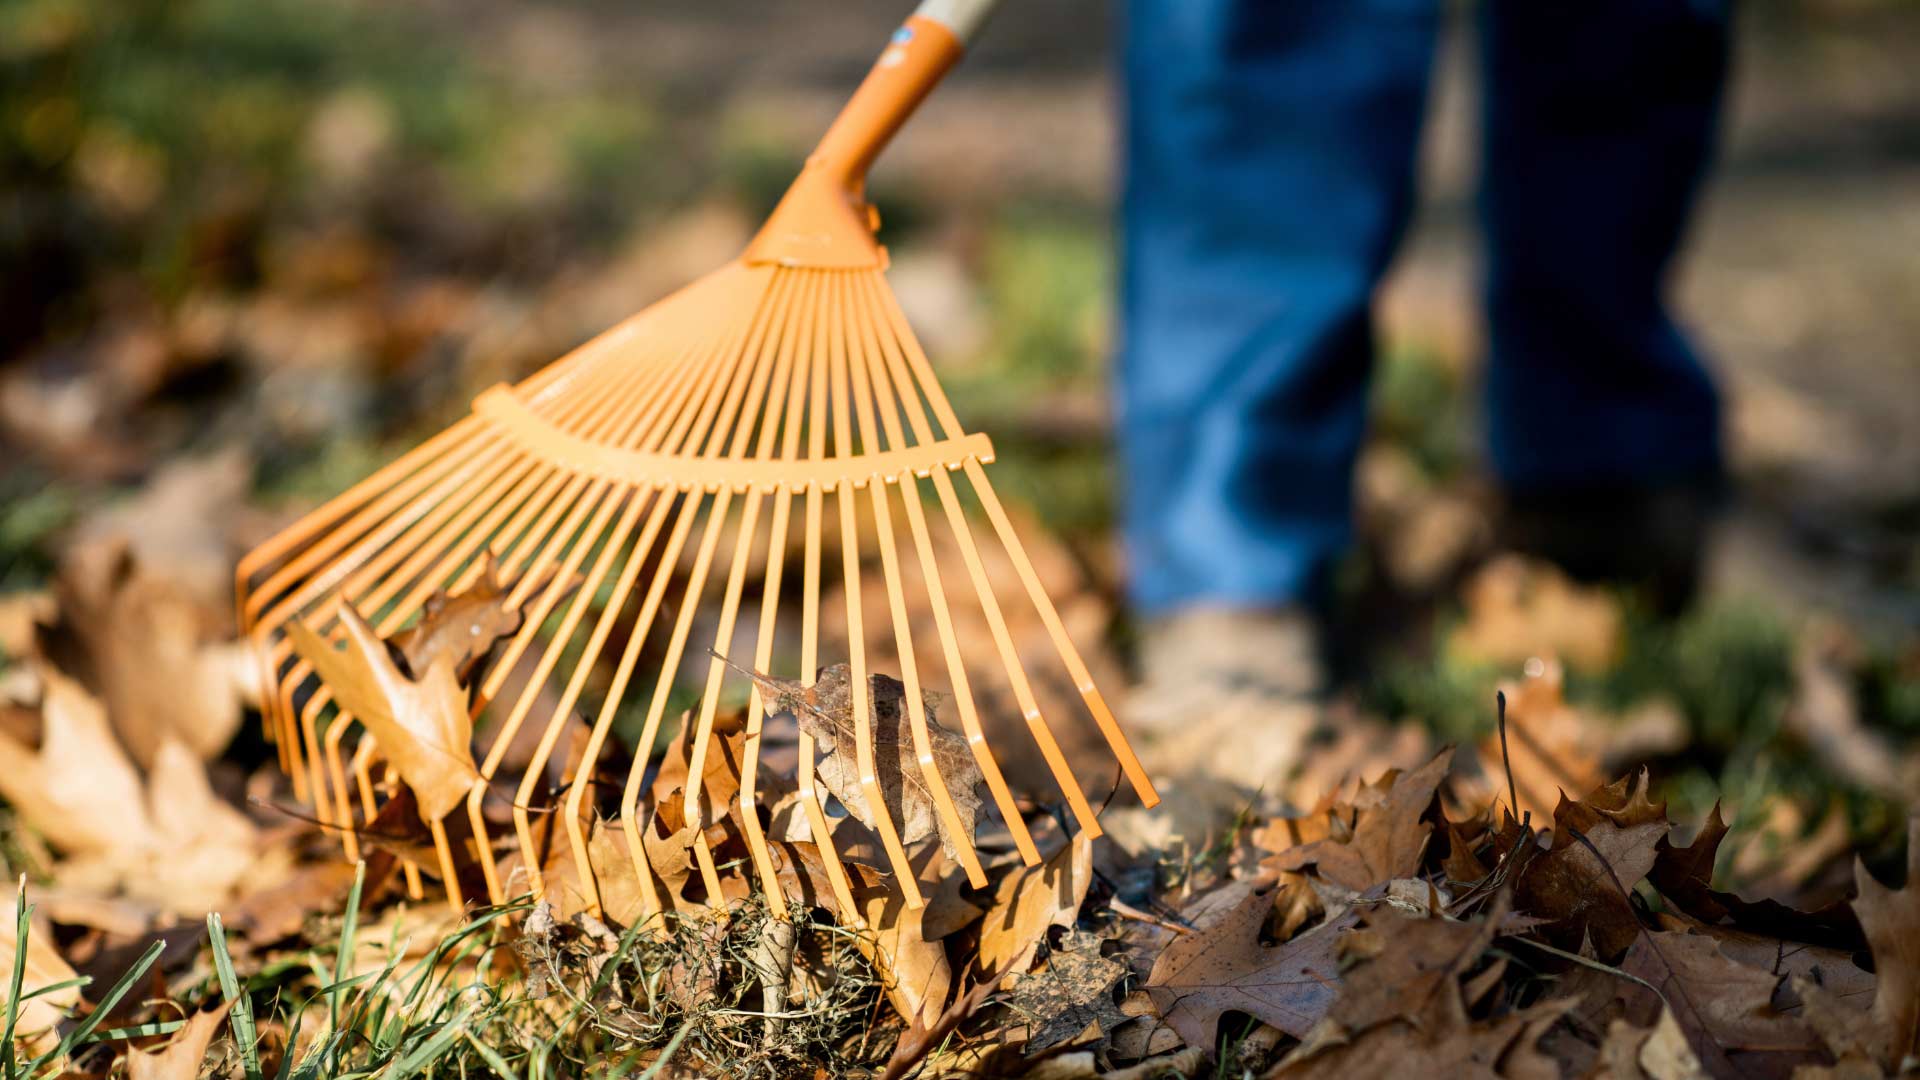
[1263,748,1453,892]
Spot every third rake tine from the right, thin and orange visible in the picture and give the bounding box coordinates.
[854,275,1041,867]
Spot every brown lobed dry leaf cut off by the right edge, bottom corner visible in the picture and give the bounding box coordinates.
[1793,813,1920,1074]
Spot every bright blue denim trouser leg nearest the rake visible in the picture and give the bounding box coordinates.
[1119,0,1438,611]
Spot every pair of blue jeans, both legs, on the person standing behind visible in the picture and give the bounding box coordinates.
[1119,0,1728,613]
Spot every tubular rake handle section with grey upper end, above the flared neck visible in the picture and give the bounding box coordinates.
[808,0,998,192]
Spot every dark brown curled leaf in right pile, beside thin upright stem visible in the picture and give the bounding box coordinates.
[1515,778,1670,959]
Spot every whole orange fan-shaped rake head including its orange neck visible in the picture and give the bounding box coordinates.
[226,0,1156,920]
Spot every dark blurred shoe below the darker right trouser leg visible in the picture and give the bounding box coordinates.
[1500,479,1726,615]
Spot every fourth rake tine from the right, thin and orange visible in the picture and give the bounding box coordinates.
[833,269,987,888]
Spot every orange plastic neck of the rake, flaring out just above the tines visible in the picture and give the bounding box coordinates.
[745,13,970,269]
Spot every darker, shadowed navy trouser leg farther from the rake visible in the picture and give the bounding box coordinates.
[1480,0,1728,494]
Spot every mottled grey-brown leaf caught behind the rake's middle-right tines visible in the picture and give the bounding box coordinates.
[739,663,985,859]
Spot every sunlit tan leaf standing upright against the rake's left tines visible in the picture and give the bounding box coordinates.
[286,601,480,822]
